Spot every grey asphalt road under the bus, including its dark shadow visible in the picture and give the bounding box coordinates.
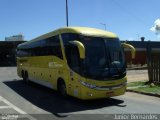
[0,67,160,120]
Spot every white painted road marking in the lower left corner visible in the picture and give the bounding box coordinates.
[0,96,37,120]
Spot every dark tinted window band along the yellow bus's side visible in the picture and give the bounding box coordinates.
[17,35,63,59]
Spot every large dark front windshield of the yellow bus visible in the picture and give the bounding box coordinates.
[62,34,126,80]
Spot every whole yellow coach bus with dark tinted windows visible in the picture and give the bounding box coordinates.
[17,27,135,100]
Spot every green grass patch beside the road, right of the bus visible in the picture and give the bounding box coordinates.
[127,81,160,95]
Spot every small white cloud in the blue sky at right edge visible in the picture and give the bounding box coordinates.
[150,19,160,36]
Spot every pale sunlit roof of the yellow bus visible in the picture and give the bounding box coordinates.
[18,27,118,47]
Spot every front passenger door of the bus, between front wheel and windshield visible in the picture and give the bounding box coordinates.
[65,45,81,97]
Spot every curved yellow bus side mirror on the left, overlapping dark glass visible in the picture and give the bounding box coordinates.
[69,40,85,59]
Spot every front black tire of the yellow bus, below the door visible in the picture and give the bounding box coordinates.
[58,80,67,97]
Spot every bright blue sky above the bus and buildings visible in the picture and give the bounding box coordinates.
[0,0,160,41]
